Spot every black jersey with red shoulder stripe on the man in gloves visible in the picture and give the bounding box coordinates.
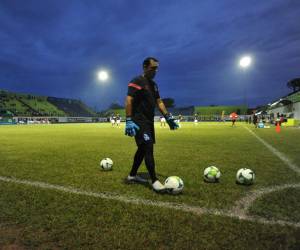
[127,76,160,123]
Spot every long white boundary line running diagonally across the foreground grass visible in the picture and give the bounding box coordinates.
[0,176,300,228]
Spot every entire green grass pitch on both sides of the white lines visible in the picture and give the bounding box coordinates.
[0,123,300,249]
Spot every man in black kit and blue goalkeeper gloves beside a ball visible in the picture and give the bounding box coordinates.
[125,57,178,192]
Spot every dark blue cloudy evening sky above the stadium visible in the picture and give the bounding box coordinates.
[0,0,300,109]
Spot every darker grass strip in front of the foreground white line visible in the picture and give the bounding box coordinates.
[0,184,300,249]
